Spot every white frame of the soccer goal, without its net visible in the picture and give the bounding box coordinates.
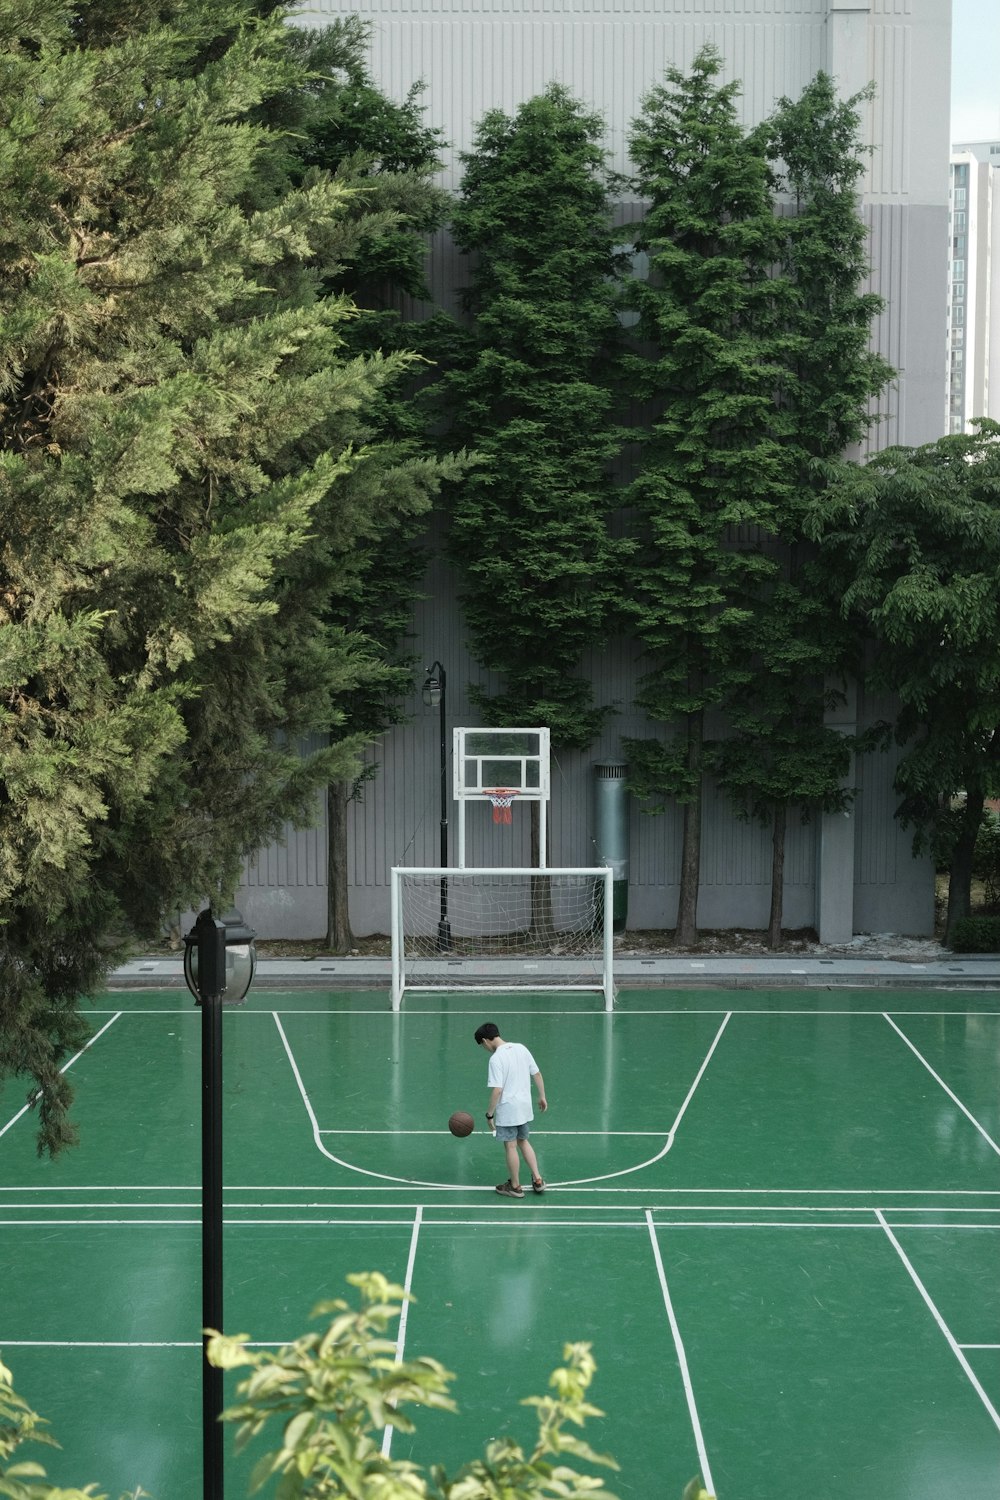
[390,866,615,1011]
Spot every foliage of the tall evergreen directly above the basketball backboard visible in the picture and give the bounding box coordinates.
[442,84,621,786]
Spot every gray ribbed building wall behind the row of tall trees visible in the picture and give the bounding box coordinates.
[240,0,951,942]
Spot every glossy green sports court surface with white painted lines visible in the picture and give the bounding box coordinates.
[0,989,1000,1500]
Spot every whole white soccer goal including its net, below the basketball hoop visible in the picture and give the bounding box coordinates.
[391,866,615,1011]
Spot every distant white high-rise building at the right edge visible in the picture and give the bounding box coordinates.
[946,141,1000,432]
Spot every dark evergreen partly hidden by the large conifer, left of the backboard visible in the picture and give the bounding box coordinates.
[257,17,463,953]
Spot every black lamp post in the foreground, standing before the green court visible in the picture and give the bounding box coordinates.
[184,908,256,1500]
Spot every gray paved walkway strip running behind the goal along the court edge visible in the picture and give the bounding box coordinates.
[108,954,1000,990]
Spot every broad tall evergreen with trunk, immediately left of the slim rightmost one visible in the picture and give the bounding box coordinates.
[627,48,789,945]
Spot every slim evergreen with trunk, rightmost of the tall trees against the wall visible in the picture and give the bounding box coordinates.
[714,74,892,947]
